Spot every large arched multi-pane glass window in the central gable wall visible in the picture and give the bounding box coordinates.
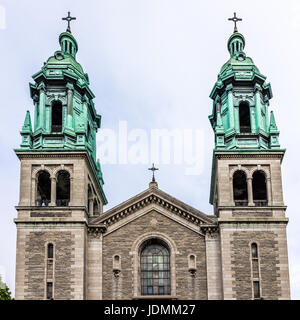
[140,239,171,295]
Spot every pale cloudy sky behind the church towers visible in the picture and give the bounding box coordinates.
[0,0,300,299]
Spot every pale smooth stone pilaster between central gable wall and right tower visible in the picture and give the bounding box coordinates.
[205,229,223,300]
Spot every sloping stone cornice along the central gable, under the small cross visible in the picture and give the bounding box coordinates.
[89,187,217,230]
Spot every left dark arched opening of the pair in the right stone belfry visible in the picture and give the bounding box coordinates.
[233,170,248,206]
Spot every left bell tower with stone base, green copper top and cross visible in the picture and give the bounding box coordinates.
[15,14,107,299]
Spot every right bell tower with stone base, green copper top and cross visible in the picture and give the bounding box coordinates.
[209,15,290,299]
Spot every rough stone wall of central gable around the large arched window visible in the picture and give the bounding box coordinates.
[103,211,207,299]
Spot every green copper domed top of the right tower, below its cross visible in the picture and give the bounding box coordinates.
[209,30,280,152]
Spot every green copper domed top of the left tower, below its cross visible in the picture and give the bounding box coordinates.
[16,31,107,203]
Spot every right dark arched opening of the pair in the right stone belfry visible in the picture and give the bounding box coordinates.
[252,170,268,206]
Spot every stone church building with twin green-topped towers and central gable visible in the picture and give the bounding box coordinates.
[15,15,290,300]
